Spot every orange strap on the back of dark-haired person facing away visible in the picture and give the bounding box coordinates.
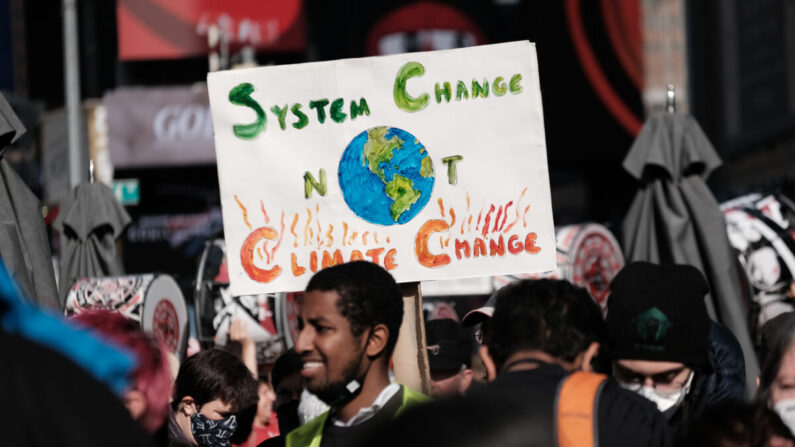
[555,372,607,447]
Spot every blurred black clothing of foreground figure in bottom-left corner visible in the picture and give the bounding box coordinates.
[0,329,151,447]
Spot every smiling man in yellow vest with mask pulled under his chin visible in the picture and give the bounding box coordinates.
[285,261,427,447]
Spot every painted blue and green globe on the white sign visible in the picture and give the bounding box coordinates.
[338,126,434,225]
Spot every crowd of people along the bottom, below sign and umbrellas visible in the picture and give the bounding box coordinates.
[7,261,795,447]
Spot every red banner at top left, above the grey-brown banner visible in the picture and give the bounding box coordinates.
[116,0,306,61]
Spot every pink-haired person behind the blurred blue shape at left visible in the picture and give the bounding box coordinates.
[72,310,172,435]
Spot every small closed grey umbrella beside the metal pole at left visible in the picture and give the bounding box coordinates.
[53,183,130,306]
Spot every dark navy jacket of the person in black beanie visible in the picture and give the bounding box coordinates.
[669,321,745,431]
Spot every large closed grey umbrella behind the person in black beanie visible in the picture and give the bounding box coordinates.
[622,113,759,392]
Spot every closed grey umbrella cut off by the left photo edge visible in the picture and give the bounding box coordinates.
[0,94,59,308]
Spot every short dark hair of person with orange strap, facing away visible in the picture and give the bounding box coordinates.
[486,279,607,367]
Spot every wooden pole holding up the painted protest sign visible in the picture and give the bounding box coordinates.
[392,282,431,395]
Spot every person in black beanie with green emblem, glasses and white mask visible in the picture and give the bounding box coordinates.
[606,262,745,431]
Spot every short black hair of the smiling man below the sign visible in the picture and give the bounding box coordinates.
[306,261,403,358]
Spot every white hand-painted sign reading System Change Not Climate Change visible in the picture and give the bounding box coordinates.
[207,42,555,295]
